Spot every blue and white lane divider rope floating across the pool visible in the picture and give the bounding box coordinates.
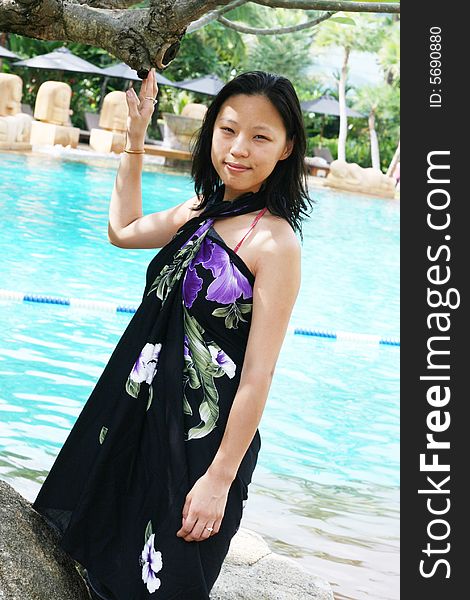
[0,288,400,346]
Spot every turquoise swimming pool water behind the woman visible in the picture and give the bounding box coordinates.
[0,153,399,600]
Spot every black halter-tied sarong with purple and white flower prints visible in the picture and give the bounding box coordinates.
[33,188,266,600]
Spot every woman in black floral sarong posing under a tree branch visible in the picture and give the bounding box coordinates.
[34,70,309,600]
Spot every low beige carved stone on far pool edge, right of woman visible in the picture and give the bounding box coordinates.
[325,160,395,198]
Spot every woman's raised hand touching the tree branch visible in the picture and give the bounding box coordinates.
[126,69,158,147]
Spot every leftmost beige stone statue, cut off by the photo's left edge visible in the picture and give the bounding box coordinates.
[0,73,32,150]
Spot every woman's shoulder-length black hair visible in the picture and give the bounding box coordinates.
[191,71,314,240]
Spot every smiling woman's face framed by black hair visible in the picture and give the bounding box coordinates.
[211,94,293,200]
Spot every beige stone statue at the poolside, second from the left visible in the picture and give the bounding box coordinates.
[31,81,80,148]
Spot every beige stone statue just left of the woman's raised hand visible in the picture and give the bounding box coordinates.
[90,91,127,154]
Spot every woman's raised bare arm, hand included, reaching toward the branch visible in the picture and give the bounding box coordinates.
[108,69,199,248]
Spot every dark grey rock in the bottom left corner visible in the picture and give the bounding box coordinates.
[0,480,90,600]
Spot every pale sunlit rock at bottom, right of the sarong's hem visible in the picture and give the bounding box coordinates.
[210,528,333,600]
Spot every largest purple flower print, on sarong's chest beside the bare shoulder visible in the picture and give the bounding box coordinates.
[203,242,253,304]
